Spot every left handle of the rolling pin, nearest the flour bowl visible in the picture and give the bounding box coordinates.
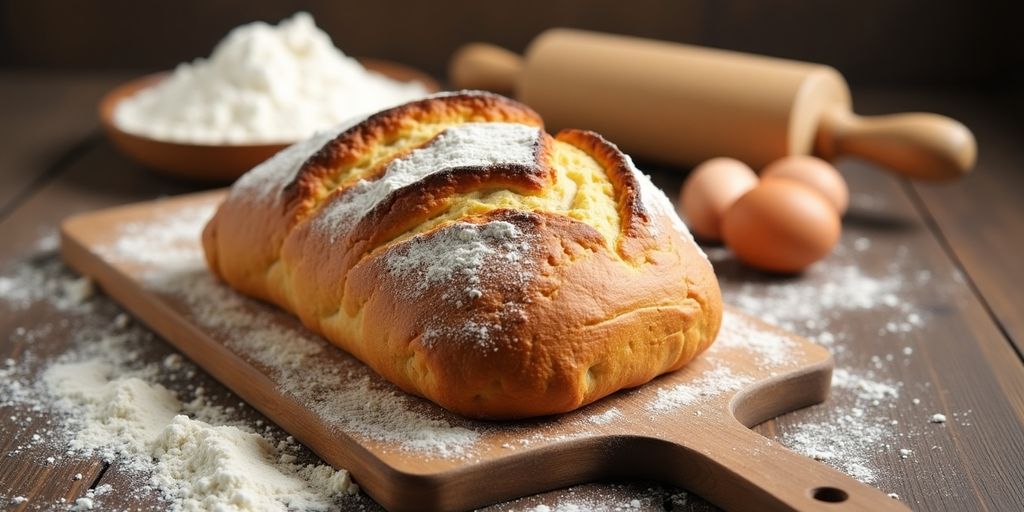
[449,43,523,96]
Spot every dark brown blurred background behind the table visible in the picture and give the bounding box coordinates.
[0,0,1024,91]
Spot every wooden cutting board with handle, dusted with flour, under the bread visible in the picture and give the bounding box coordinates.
[61,191,905,511]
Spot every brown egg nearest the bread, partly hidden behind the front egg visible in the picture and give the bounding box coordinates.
[679,158,758,240]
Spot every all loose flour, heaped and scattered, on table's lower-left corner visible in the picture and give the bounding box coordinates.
[0,262,357,511]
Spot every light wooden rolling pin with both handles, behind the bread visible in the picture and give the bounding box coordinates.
[449,29,977,180]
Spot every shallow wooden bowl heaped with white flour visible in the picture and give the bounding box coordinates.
[99,12,439,182]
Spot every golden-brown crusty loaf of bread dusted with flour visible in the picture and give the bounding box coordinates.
[203,92,722,419]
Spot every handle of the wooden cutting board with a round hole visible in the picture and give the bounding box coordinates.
[663,420,909,512]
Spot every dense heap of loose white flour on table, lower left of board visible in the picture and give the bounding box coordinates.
[42,327,357,510]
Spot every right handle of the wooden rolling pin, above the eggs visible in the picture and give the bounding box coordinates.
[815,109,978,181]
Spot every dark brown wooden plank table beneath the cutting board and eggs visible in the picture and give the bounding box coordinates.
[0,73,1024,510]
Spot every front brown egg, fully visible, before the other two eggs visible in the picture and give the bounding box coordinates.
[722,179,840,272]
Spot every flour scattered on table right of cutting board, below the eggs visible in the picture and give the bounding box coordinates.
[709,238,931,483]
